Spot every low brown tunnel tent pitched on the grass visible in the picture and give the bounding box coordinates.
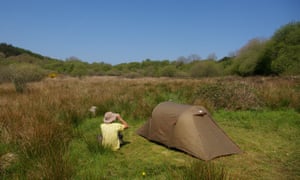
[137,102,241,160]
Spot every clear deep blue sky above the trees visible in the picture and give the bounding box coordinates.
[0,0,300,64]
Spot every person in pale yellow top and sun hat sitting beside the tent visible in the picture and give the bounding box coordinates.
[100,112,128,151]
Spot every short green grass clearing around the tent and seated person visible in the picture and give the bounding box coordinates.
[68,110,300,179]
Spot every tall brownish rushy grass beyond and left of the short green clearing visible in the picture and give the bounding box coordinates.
[0,77,300,179]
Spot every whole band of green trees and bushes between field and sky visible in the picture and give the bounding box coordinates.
[0,22,300,79]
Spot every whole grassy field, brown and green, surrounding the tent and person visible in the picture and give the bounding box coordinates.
[0,77,300,179]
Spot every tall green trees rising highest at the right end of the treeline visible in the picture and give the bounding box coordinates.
[221,22,300,76]
